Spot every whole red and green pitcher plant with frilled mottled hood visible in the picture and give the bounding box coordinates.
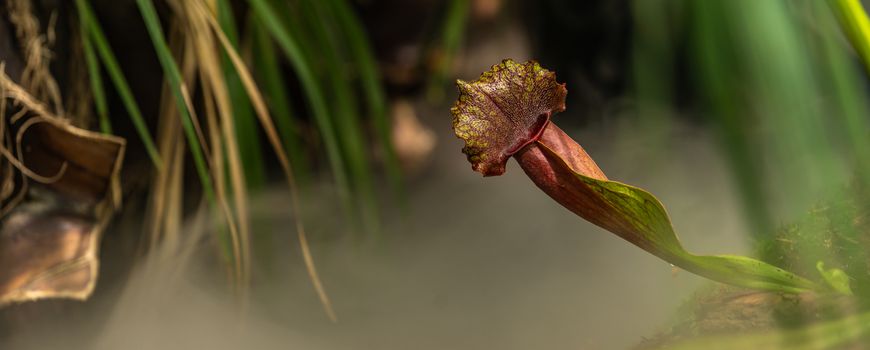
[451,59,848,293]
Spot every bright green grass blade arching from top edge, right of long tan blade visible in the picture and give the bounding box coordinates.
[248,0,350,203]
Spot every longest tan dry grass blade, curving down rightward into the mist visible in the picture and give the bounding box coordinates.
[209,5,337,322]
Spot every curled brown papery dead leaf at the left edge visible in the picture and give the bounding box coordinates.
[0,67,125,307]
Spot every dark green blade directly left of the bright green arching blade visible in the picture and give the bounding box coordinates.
[248,17,309,187]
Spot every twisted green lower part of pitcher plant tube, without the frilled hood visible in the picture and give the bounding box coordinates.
[536,135,823,293]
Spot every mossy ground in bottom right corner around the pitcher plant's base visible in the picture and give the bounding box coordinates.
[638,186,870,349]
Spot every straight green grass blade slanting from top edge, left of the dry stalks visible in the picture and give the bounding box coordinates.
[76,0,163,169]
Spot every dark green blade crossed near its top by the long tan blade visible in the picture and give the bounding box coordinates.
[217,0,265,188]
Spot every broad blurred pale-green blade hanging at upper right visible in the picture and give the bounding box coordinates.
[728,0,847,213]
